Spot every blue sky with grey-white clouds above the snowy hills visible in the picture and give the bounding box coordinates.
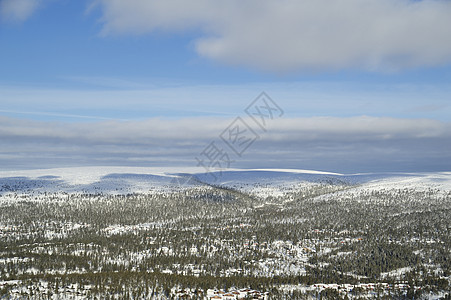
[0,0,451,173]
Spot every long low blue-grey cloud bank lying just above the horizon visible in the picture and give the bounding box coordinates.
[0,117,451,172]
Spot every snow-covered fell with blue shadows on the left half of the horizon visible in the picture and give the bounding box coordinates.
[0,167,200,195]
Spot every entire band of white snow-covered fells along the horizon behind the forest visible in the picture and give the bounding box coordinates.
[0,167,451,197]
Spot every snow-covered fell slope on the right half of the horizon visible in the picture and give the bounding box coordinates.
[196,170,451,198]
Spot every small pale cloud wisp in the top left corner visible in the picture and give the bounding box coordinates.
[0,0,40,22]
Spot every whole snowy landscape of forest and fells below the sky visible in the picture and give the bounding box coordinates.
[0,167,451,299]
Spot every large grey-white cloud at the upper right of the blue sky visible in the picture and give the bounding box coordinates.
[92,0,451,72]
